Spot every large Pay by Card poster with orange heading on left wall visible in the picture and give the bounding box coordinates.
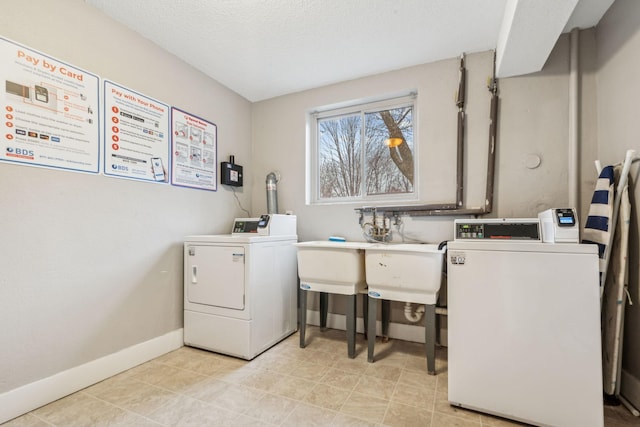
[0,38,100,173]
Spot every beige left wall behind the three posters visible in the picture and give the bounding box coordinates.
[0,0,252,402]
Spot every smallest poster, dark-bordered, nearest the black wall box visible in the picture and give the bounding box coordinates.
[171,108,217,191]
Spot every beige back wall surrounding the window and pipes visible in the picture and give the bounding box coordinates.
[252,36,594,322]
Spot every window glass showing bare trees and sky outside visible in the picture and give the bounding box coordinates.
[317,106,414,200]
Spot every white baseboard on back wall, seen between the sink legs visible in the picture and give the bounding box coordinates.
[307,310,447,346]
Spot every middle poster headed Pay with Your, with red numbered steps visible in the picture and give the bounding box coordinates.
[104,80,169,182]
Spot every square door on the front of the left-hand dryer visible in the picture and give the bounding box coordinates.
[185,245,245,310]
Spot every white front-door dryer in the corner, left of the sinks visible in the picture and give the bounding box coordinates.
[184,215,297,360]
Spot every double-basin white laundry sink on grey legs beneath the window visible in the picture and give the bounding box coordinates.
[296,241,445,374]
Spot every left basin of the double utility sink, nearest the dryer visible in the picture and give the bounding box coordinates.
[295,241,372,295]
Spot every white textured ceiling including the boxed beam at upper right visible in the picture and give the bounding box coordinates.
[85,0,613,102]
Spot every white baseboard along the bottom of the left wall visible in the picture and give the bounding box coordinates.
[0,328,184,424]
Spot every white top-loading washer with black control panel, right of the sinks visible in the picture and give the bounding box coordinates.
[447,218,604,427]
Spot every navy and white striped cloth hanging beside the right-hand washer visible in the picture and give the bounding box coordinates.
[582,166,615,284]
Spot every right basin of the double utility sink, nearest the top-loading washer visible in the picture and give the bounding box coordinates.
[365,243,446,305]
